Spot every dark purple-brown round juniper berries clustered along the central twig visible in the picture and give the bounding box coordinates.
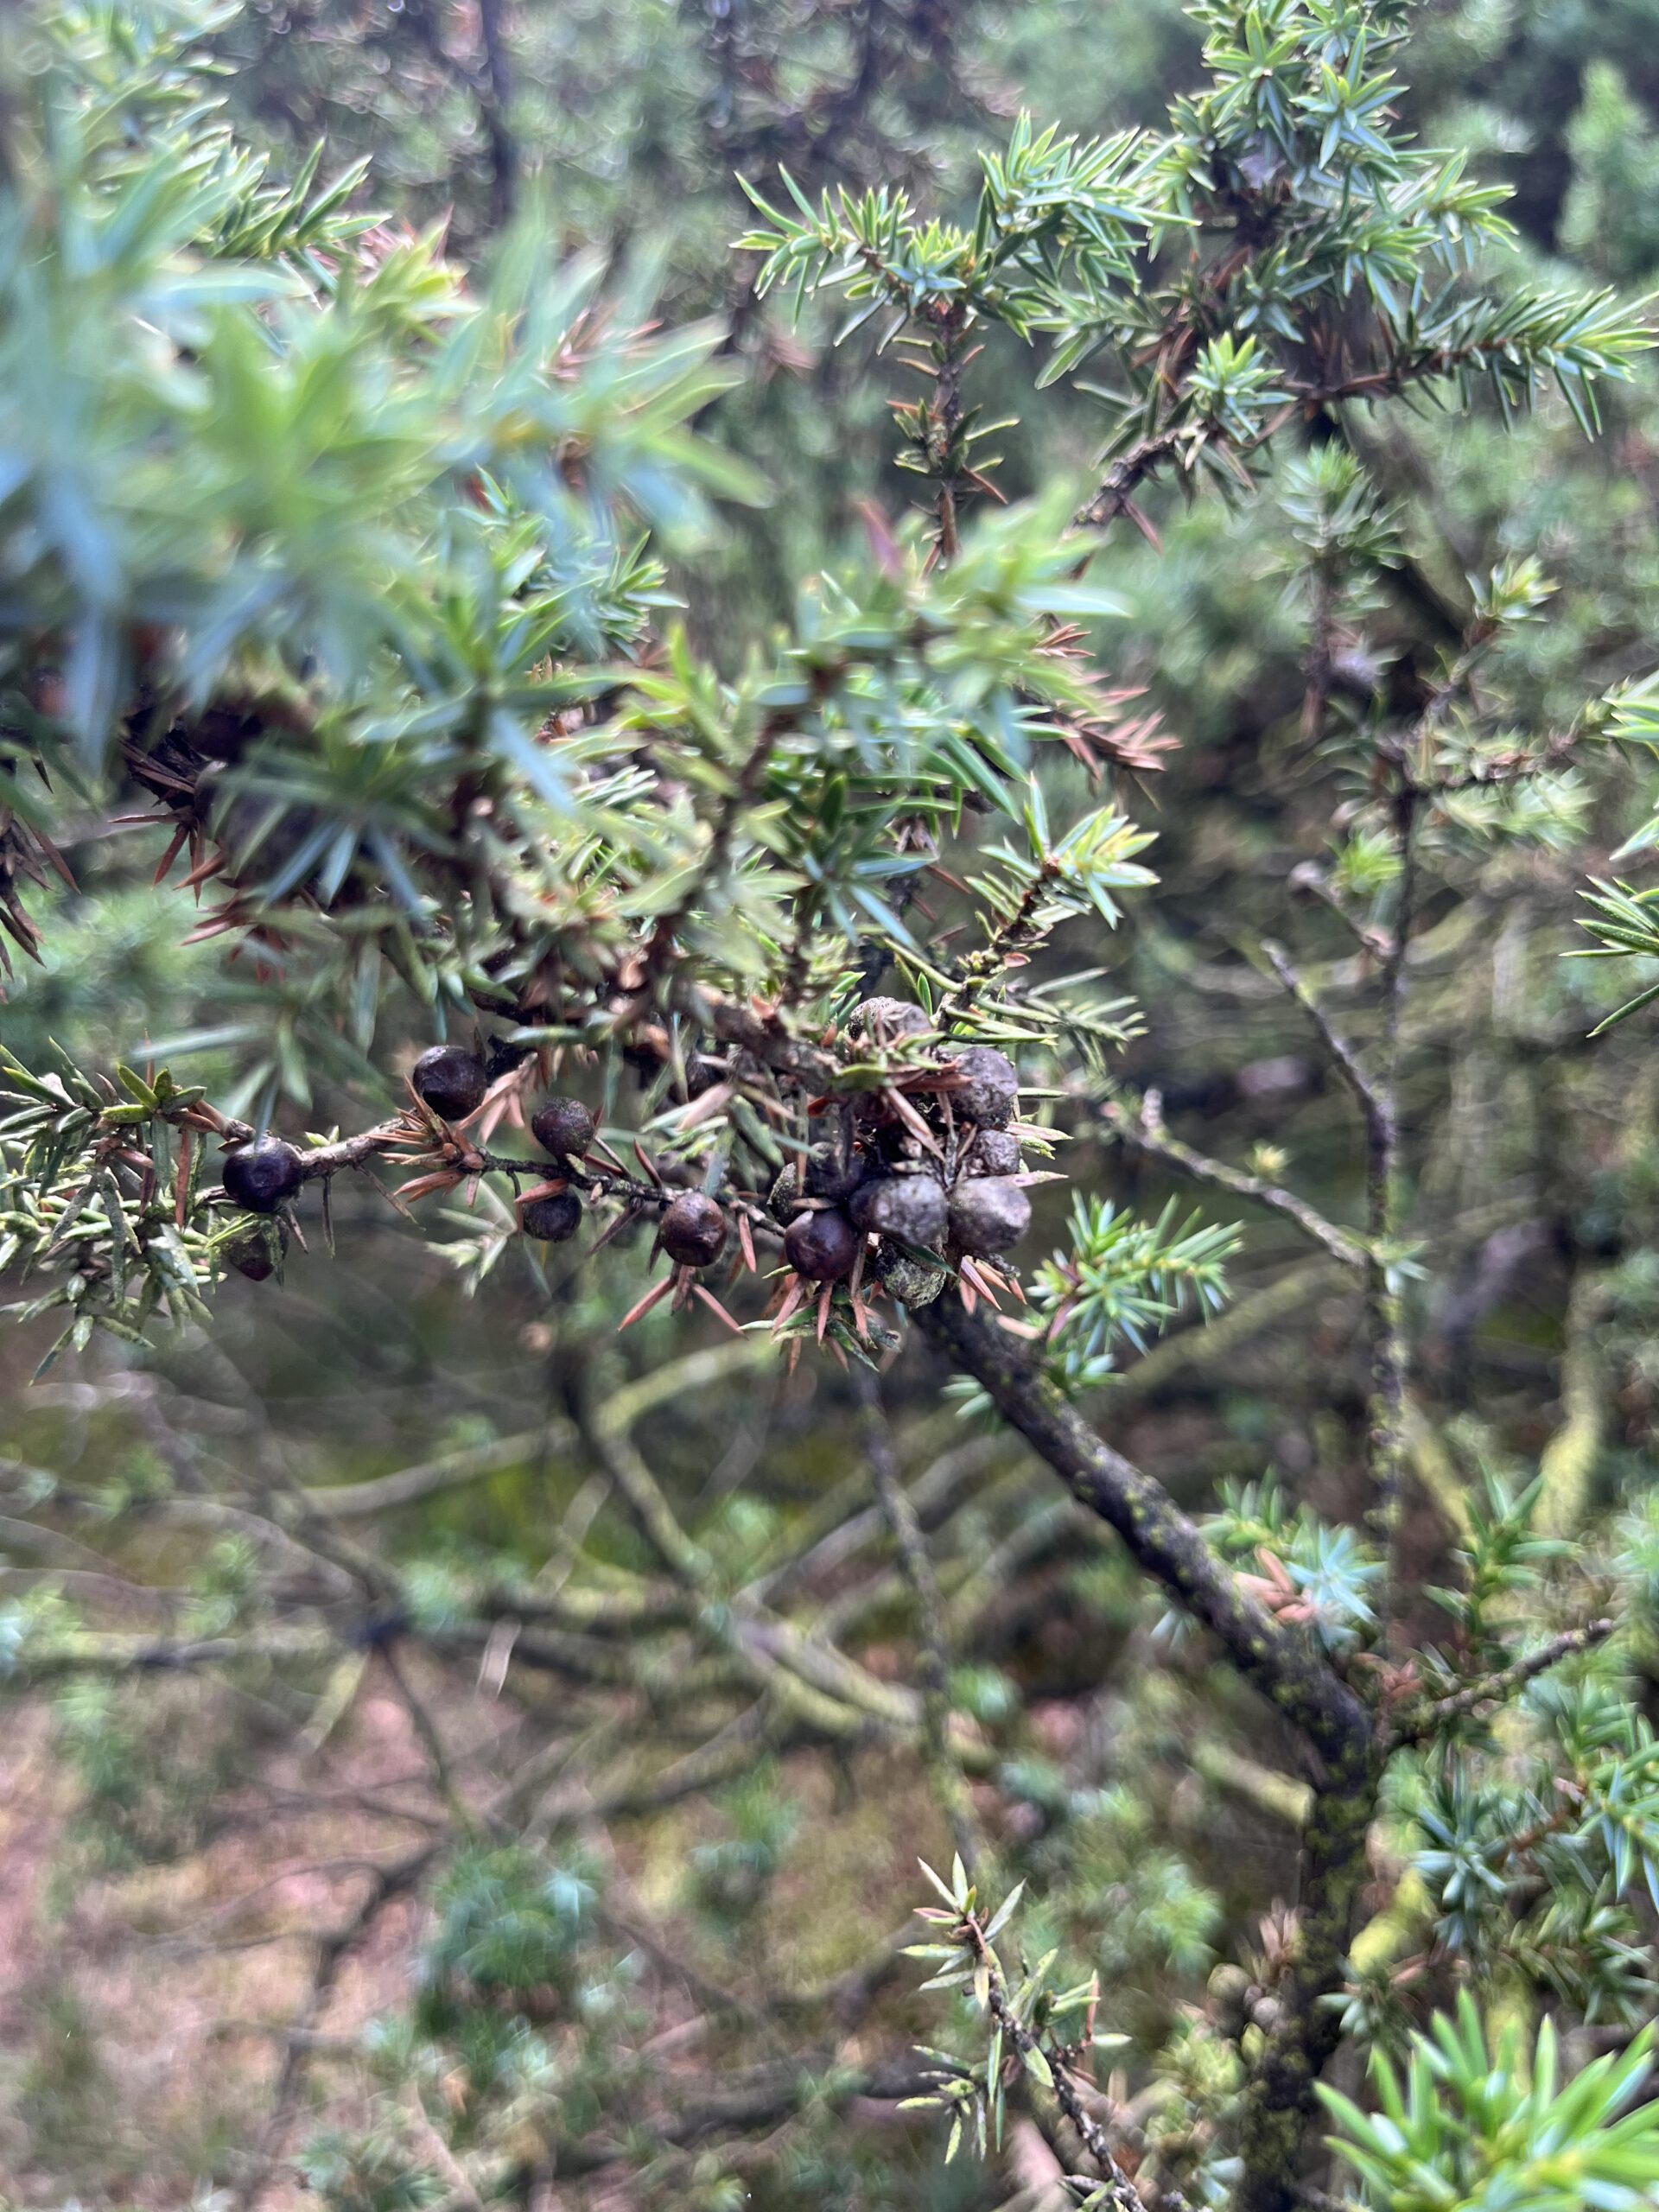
[204,998,1039,1340]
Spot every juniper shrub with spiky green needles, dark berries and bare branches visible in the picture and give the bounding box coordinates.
[0,0,1659,2212]
